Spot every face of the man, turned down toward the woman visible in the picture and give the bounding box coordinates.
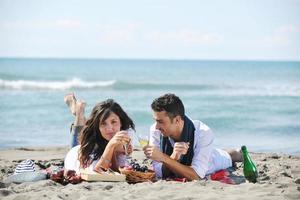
[153,111,178,137]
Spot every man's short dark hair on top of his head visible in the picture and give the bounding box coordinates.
[151,93,184,120]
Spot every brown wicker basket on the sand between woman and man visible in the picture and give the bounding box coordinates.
[119,167,155,183]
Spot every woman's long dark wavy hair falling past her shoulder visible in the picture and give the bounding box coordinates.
[79,99,135,167]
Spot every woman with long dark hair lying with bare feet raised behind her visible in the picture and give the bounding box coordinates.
[64,93,135,173]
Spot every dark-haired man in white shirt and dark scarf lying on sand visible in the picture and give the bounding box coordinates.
[143,94,242,180]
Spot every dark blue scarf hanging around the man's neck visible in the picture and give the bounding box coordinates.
[160,116,195,166]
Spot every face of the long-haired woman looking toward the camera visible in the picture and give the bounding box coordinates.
[99,112,121,141]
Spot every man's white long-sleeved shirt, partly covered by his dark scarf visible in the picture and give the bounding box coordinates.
[149,120,232,178]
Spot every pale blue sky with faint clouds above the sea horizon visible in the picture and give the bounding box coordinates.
[0,0,300,61]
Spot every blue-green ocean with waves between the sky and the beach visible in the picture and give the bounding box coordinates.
[0,58,300,154]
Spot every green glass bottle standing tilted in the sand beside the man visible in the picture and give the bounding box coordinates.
[242,146,258,183]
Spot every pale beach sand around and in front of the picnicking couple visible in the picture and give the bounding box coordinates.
[0,147,300,200]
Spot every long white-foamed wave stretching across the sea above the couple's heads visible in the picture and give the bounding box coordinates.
[0,78,300,97]
